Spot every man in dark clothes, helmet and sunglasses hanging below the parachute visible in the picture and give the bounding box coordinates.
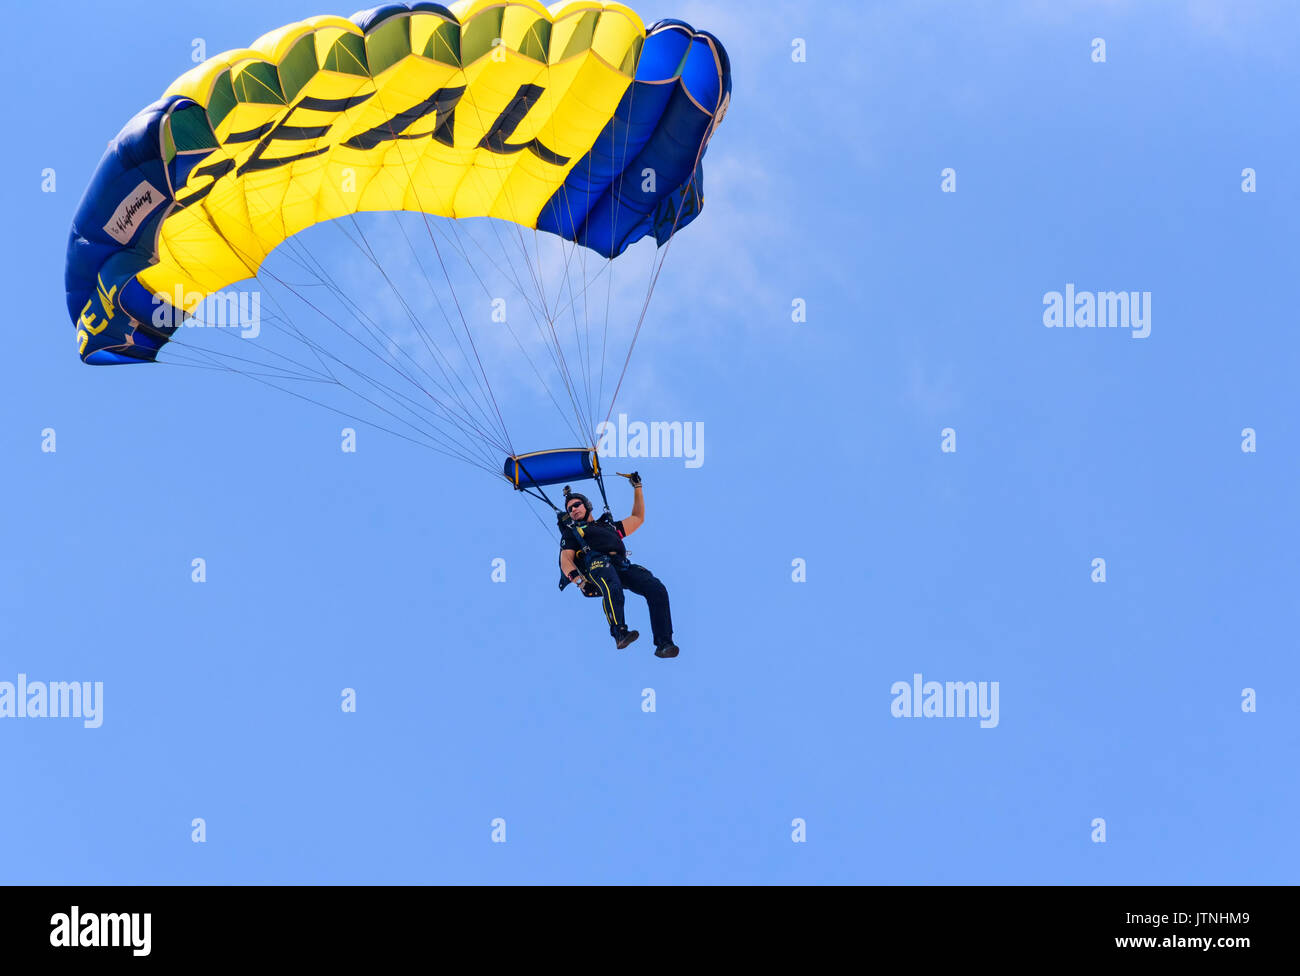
[559,472,679,658]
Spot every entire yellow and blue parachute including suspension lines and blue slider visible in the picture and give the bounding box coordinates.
[65,0,731,526]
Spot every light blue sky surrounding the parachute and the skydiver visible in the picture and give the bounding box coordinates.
[0,0,1300,884]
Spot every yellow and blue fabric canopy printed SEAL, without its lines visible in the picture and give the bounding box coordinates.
[65,0,731,365]
